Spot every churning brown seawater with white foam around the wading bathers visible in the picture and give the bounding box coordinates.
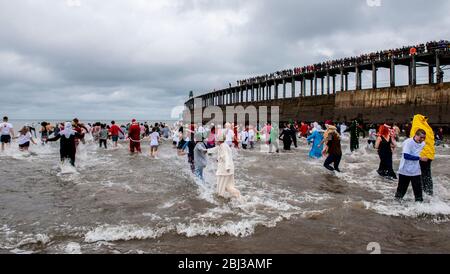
[0,134,450,253]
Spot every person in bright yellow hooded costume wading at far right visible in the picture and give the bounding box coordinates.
[410,114,436,195]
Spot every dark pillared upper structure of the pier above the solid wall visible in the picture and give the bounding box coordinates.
[185,47,450,109]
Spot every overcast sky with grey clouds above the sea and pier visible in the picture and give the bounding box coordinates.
[0,0,450,120]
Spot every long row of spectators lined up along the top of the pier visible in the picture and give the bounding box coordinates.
[229,40,450,88]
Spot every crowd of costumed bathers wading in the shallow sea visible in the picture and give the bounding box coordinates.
[0,115,445,202]
